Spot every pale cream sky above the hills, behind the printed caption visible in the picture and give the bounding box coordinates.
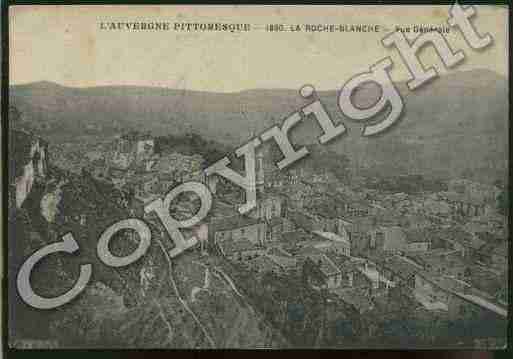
[9,5,508,92]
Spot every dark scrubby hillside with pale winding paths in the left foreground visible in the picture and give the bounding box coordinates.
[9,162,289,348]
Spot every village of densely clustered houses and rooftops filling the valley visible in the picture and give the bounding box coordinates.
[12,127,508,347]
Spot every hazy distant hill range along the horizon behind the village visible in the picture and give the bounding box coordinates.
[11,70,508,181]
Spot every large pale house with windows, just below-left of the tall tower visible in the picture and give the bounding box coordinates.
[210,215,267,245]
